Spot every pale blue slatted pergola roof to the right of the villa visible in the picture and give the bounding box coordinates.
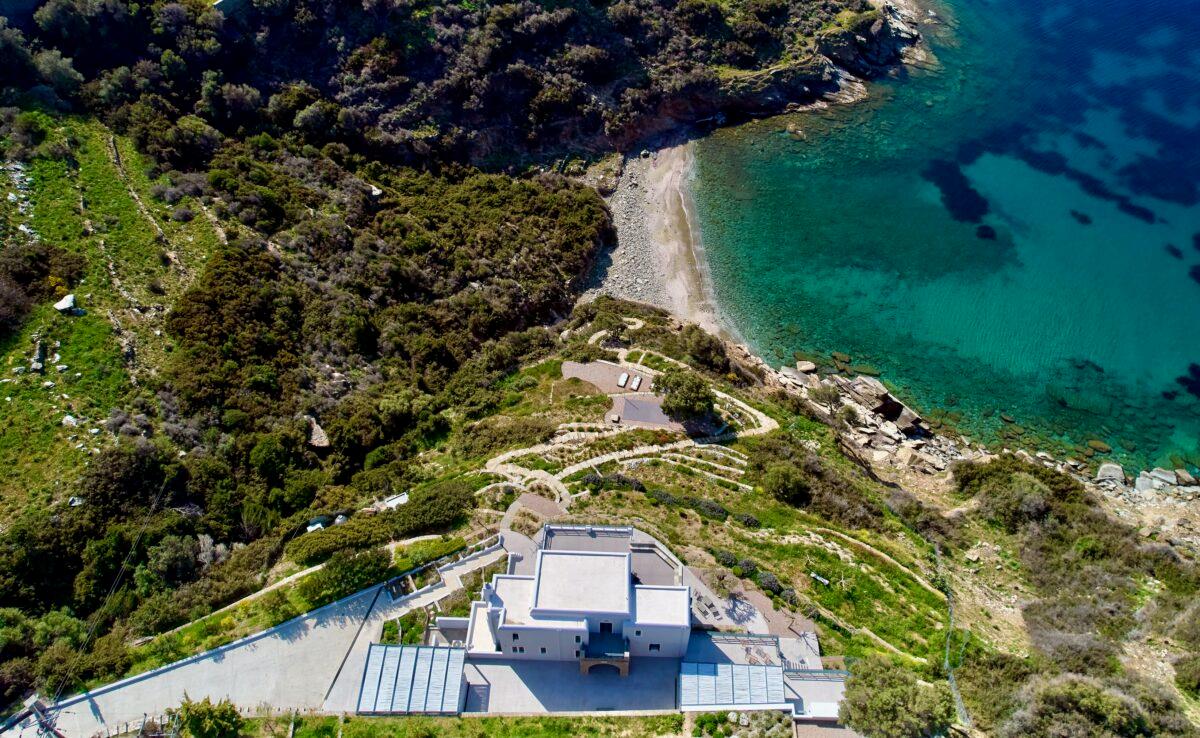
[679,661,786,709]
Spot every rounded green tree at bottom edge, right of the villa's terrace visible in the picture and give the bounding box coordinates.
[838,655,954,738]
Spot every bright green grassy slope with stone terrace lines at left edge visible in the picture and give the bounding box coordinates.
[0,118,218,515]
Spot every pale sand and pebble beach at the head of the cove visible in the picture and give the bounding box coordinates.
[584,143,728,335]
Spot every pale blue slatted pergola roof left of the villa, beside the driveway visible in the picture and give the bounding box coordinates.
[358,643,467,715]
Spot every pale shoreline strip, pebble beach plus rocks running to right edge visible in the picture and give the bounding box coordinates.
[580,135,1200,550]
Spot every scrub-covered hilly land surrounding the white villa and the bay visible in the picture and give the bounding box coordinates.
[0,0,1196,734]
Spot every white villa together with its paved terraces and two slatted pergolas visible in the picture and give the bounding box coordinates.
[356,524,853,738]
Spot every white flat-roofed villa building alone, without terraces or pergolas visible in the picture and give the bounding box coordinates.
[464,548,691,672]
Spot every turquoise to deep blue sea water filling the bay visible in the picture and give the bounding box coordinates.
[692,0,1200,467]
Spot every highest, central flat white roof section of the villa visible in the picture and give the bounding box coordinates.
[533,550,631,613]
